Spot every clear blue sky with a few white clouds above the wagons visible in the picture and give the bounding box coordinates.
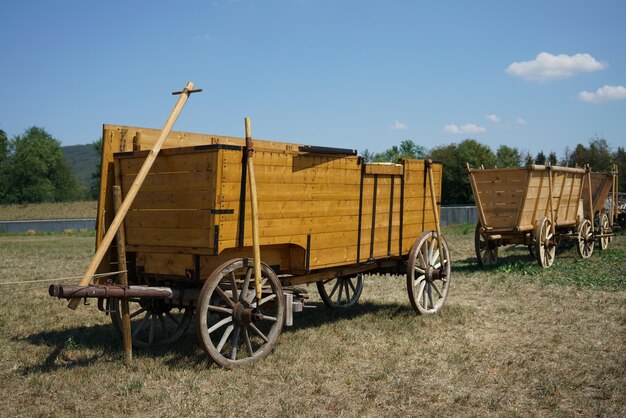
[0,0,626,156]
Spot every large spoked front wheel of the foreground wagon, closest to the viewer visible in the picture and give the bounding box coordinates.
[196,258,285,368]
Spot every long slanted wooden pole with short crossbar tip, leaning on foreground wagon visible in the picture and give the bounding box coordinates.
[67,81,202,309]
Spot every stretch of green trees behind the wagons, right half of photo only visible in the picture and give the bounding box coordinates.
[362,136,626,205]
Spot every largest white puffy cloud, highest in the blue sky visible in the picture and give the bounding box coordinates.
[505,52,608,81]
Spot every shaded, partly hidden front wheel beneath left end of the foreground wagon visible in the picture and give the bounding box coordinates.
[109,298,193,348]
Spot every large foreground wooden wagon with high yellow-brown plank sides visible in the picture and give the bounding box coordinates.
[50,90,450,367]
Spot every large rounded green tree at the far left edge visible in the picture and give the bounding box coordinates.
[3,126,80,203]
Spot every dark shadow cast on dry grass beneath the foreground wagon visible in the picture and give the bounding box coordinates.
[18,299,416,375]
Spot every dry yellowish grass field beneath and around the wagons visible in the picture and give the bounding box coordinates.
[0,226,626,417]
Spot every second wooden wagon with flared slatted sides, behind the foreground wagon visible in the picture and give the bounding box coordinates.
[466,165,594,267]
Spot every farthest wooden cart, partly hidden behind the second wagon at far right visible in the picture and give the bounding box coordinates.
[582,165,619,250]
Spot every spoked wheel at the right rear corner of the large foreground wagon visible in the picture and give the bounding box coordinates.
[406,231,451,315]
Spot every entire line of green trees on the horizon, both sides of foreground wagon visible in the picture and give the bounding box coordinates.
[0,126,626,204]
